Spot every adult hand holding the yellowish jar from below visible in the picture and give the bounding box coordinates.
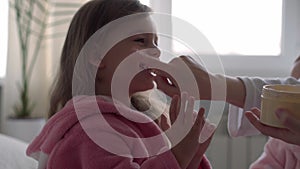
[245,108,300,146]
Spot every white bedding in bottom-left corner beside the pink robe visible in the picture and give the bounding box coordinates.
[0,134,38,169]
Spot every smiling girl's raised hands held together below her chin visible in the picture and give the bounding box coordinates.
[161,93,210,168]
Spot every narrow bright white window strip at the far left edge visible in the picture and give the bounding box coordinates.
[0,0,8,79]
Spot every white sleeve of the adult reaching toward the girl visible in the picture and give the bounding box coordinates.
[227,77,300,137]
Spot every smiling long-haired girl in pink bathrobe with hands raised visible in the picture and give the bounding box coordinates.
[27,0,210,169]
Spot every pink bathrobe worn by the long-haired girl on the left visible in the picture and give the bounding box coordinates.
[26,96,211,169]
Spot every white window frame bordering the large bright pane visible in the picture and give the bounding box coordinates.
[150,0,300,77]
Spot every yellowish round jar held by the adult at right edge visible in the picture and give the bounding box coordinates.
[260,84,300,128]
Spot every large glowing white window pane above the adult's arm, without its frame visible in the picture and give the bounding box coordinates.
[172,0,282,55]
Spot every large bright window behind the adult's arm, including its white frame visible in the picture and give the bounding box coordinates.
[150,0,300,77]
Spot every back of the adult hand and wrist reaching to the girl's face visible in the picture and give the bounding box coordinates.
[169,56,246,107]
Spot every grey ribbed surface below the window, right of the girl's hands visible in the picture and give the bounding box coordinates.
[206,107,268,169]
